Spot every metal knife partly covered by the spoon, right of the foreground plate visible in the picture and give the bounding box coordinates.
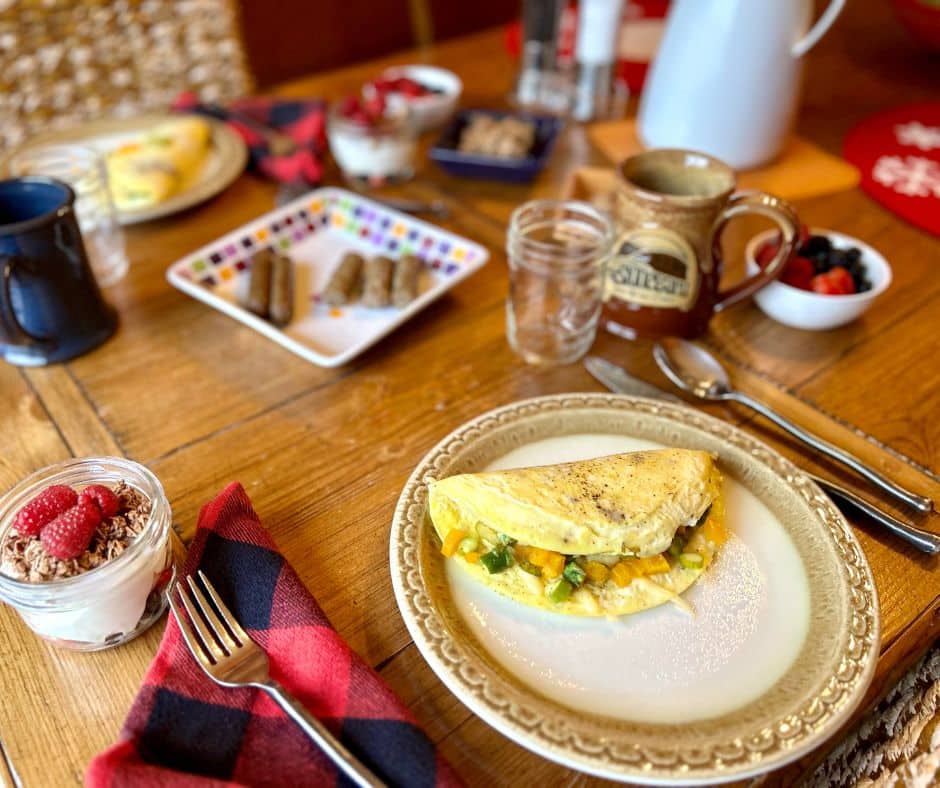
[584,356,940,555]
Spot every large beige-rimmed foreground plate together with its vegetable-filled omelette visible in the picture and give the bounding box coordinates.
[390,394,880,785]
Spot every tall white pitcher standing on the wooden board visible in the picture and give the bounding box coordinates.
[638,0,845,169]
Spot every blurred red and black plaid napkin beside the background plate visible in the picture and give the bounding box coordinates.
[173,93,326,186]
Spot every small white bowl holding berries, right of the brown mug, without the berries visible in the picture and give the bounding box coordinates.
[746,227,891,331]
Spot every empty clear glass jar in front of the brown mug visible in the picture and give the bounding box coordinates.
[506,200,614,364]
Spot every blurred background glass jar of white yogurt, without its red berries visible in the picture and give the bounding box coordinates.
[326,104,418,186]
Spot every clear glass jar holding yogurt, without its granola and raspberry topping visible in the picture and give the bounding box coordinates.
[0,457,175,651]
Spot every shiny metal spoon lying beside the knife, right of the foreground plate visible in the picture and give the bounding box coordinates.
[653,339,933,512]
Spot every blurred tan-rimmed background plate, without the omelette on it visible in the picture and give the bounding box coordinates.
[0,114,248,225]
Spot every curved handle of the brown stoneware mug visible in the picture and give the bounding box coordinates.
[711,191,800,312]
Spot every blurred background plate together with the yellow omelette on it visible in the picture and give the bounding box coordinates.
[4,113,248,225]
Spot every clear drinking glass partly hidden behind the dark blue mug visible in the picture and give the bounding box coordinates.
[10,145,128,287]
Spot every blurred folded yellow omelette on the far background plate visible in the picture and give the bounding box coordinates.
[106,116,212,211]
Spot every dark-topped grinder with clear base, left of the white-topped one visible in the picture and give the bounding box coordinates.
[512,0,570,112]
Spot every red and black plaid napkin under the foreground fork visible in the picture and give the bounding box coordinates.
[85,482,460,788]
